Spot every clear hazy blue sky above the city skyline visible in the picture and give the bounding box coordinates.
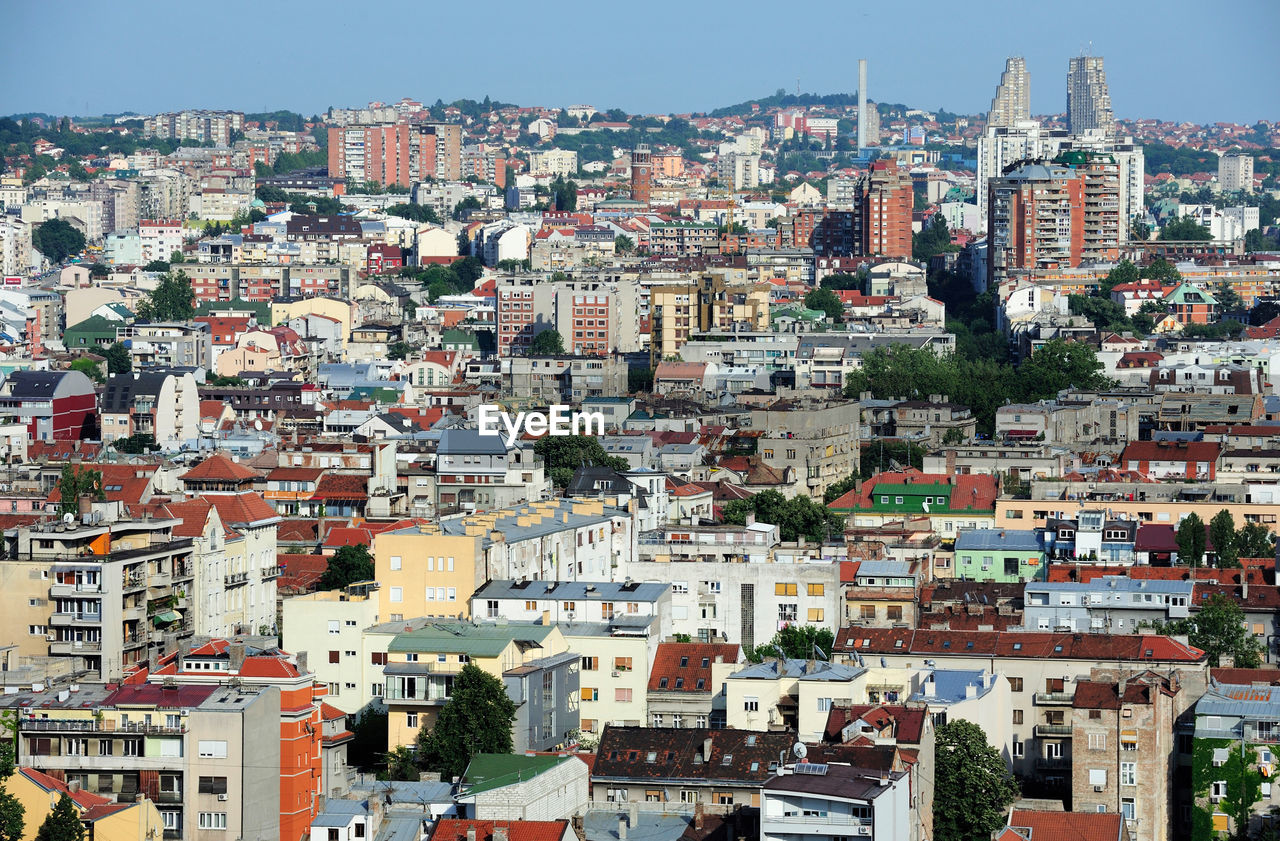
[0,0,1280,123]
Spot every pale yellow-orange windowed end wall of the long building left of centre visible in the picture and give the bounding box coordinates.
[372,525,486,622]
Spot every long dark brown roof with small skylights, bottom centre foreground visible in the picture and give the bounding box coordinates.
[591,725,795,786]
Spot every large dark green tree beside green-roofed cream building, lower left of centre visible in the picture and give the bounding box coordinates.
[417,663,516,780]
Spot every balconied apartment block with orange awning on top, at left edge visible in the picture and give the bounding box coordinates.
[0,509,201,680]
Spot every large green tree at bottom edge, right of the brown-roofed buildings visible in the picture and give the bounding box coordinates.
[933,719,1018,841]
